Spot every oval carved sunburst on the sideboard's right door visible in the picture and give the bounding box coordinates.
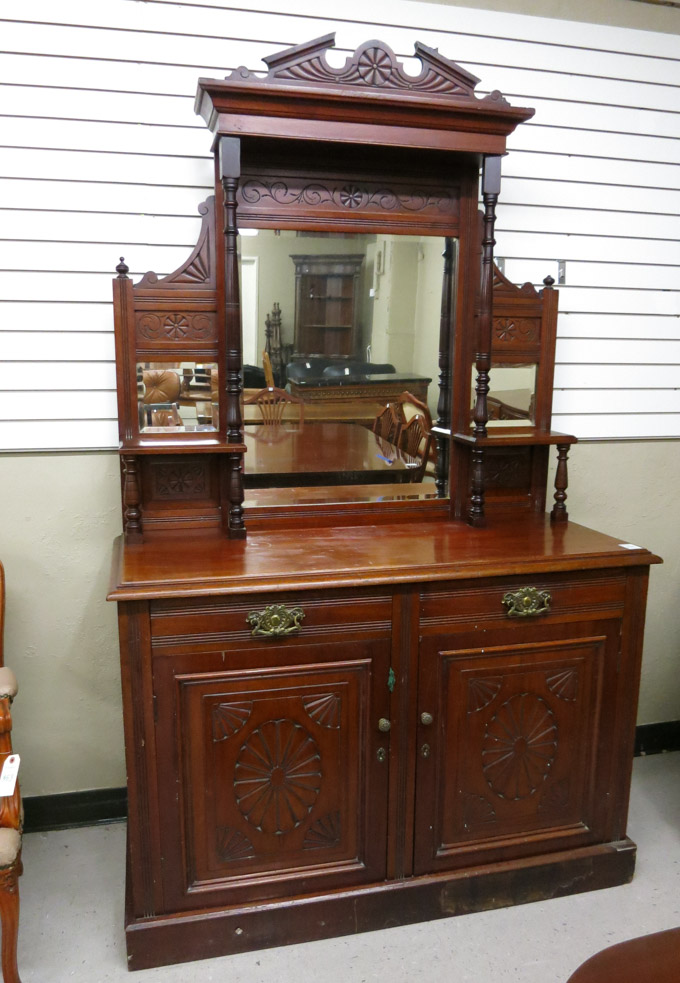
[482,693,557,801]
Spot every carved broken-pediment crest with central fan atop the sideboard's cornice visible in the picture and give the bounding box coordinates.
[227,33,508,107]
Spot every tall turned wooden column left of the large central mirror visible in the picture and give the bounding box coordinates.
[219,137,246,539]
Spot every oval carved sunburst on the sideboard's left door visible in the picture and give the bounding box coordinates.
[234,720,321,834]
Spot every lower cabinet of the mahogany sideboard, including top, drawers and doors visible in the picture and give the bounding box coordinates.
[109,517,657,969]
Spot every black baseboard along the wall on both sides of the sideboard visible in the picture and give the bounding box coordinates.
[24,720,680,833]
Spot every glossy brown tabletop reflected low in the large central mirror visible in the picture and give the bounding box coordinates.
[245,421,419,488]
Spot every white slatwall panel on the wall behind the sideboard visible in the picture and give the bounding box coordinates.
[0,0,680,450]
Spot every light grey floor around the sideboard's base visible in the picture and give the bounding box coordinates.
[19,752,680,983]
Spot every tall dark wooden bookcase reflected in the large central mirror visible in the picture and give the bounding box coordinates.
[291,254,364,355]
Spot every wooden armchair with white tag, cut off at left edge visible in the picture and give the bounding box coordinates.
[0,563,23,983]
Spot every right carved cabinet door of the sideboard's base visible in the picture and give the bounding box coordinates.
[415,621,619,873]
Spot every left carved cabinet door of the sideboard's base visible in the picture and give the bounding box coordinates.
[155,641,390,908]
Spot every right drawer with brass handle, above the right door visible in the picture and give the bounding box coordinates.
[420,570,626,633]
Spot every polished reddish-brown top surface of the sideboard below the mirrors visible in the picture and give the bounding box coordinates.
[108,516,661,601]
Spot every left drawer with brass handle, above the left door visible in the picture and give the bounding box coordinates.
[151,588,392,652]
